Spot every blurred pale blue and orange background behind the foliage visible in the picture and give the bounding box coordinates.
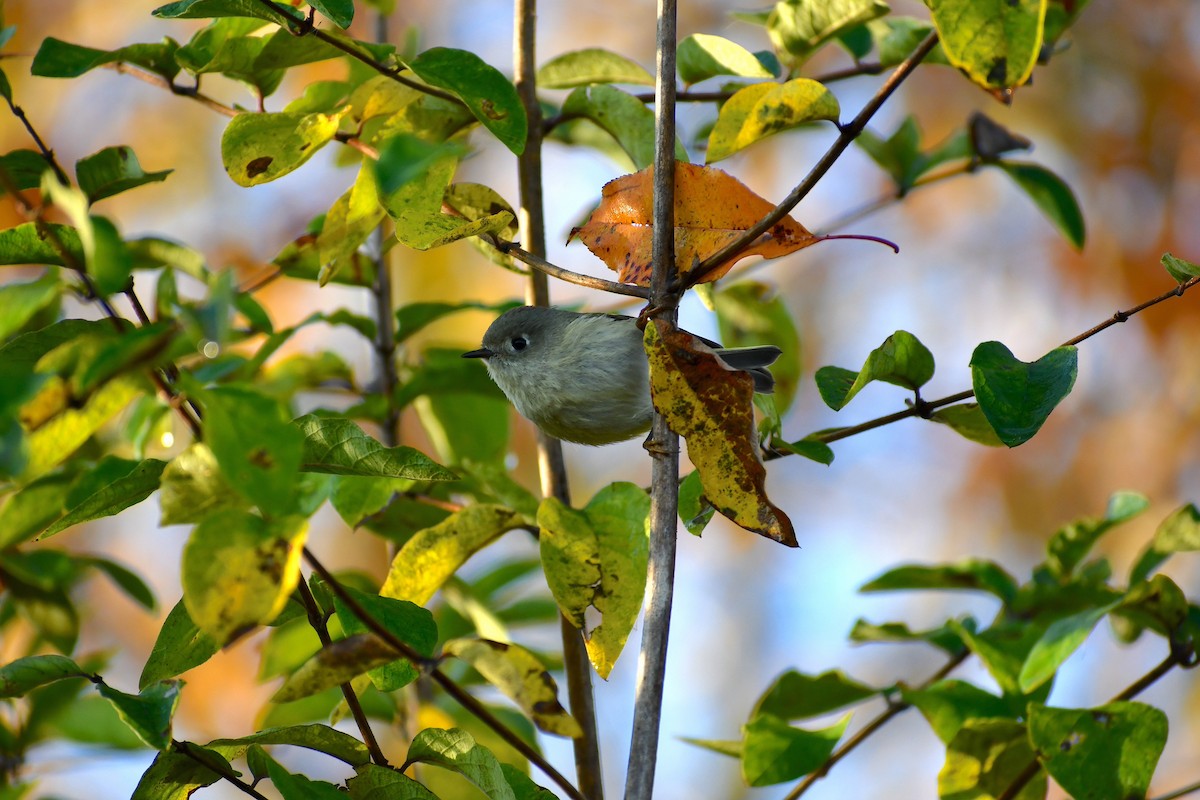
[0,0,1200,800]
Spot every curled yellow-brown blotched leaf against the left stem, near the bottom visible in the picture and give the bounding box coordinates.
[442,639,583,738]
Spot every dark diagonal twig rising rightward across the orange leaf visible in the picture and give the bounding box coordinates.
[680,32,937,288]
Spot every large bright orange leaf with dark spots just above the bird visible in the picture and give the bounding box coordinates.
[570,162,821,287]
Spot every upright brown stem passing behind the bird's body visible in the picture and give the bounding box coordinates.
[512,0,604,800]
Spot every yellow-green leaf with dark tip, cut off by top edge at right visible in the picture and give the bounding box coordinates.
[929,0,1046,90]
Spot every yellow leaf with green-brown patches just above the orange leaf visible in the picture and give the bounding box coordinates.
[704,78,841,164]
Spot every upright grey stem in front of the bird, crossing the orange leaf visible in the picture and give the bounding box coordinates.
[625,0,679,800]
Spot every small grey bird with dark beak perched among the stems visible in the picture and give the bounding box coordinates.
[462,306,780,445]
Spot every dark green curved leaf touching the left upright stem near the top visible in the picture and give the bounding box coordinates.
[408,47,528,156]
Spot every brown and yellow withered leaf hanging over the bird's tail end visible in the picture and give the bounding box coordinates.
[646,320,799,547]
